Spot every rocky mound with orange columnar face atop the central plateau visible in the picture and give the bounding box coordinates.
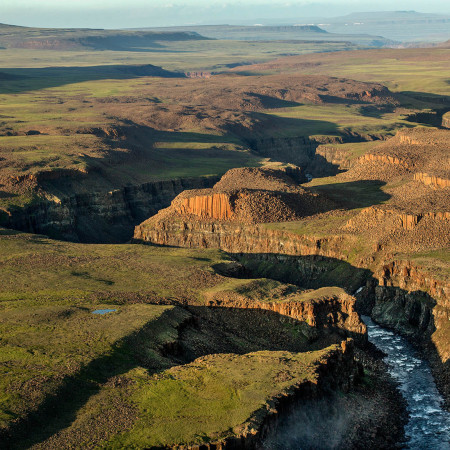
[139,168,333,229]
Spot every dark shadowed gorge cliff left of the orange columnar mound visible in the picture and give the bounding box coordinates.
[2,177,217,242]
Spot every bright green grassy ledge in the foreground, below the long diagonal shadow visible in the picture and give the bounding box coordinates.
[102,349,330,448]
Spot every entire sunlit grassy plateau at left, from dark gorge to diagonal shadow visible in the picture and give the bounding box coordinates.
[0,229,236,428]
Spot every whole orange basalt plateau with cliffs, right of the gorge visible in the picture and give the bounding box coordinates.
[134,129,450,401]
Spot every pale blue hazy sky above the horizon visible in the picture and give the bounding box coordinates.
[0,0,450,28]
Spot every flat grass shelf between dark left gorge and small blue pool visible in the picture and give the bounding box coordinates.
[0,229,234,304]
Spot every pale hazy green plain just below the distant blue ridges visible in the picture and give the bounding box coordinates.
[0,40,354,72]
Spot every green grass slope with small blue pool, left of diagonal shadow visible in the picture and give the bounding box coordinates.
[0,302,178,428]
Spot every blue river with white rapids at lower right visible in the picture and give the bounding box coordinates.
[363,316,450,450]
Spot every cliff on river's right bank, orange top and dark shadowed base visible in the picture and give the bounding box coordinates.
[368,261,450,407]
